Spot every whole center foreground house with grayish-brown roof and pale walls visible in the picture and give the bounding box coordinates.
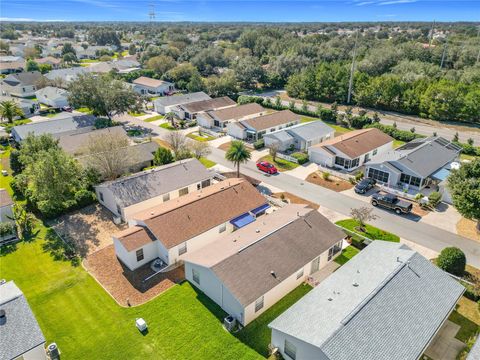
[184,204,345,326]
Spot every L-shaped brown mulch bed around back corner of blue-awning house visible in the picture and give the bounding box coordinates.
[83,244,185,306]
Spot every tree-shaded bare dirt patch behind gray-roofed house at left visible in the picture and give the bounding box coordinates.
[50,204,126,258]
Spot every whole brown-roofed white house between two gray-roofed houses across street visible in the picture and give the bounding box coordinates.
[308,128,393,171]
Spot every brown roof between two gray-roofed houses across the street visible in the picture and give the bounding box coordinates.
[313,128,393,159]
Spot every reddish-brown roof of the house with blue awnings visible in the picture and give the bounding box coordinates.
[132,179,267,249]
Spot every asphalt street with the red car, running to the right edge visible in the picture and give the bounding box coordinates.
[209,148,480,267]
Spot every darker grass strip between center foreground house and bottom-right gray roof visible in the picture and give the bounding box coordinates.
[236,284,312,357]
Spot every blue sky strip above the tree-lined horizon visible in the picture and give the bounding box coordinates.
[0,0,480,22]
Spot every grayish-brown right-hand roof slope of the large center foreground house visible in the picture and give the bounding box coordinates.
[212,210,345,306]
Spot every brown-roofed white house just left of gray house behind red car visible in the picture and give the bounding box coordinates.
[227,110,301,141]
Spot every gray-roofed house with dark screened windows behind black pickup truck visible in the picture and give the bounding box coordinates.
[365,136,462,190]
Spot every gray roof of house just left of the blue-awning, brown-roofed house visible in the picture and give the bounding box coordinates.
[95,159,212,207]
